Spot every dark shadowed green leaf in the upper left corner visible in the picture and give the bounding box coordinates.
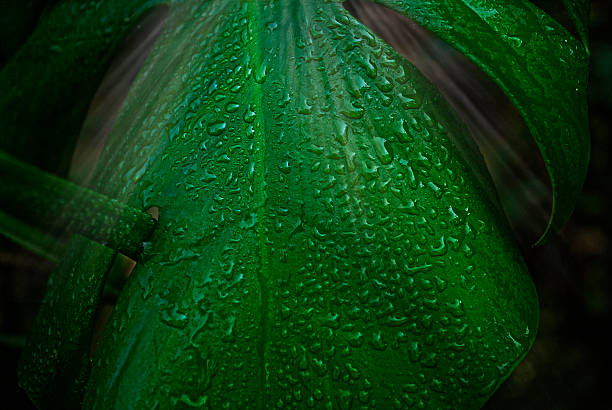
[0,0,167,176]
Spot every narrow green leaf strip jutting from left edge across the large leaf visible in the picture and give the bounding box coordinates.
[0,151,155,258]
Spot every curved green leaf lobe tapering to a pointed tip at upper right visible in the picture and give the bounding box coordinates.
[374,0,590,244]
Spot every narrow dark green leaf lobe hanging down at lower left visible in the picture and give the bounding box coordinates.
[19,235,115,409]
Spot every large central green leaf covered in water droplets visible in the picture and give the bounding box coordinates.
[81,1,535,409]
